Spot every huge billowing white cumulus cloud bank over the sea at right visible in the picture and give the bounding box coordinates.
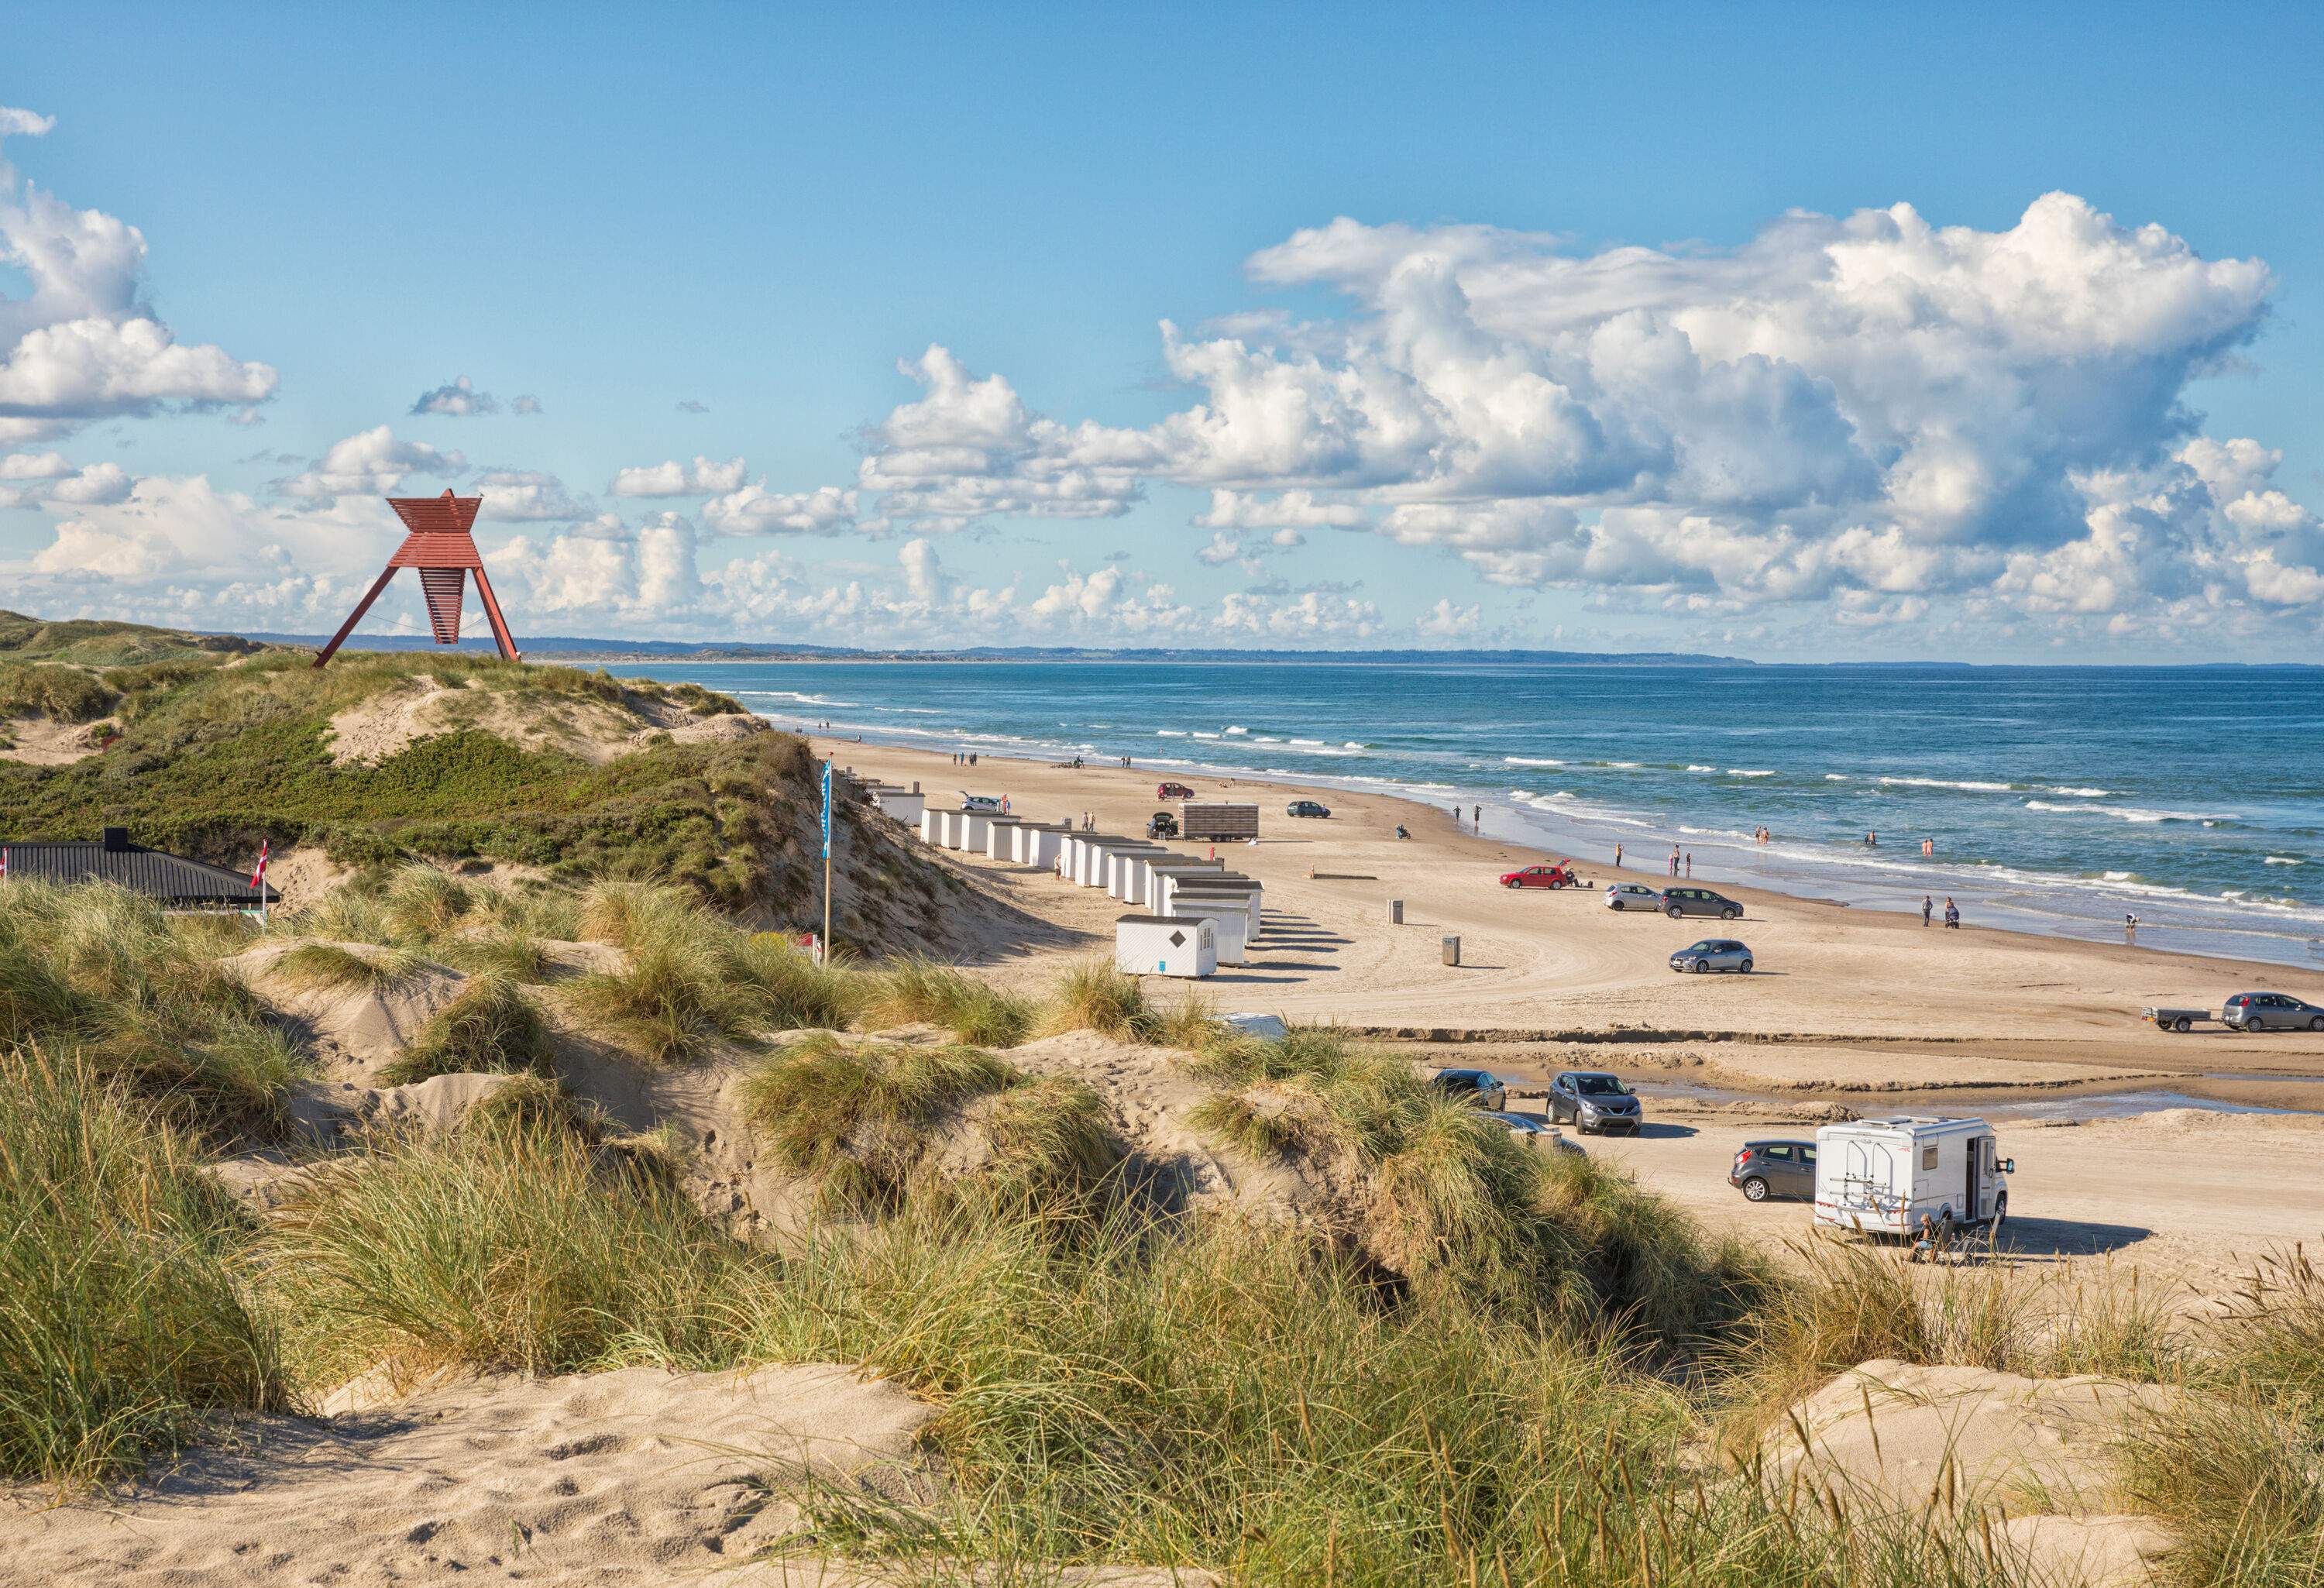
[858,193,2324,641]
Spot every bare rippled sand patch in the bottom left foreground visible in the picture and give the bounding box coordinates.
[0,1365,1208,1588]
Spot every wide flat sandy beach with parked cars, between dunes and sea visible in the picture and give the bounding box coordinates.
[816,739,2324,1277]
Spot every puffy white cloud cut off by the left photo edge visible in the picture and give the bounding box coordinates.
[0,109,277,432]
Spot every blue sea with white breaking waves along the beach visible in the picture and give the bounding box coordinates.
[611,660,2324,968]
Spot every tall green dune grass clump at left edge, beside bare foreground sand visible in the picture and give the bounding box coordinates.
[0,1049,290,1490]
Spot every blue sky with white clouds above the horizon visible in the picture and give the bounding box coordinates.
[0,2,2324,662]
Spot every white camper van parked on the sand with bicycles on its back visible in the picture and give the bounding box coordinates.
[1815,1114,2015,1237]
